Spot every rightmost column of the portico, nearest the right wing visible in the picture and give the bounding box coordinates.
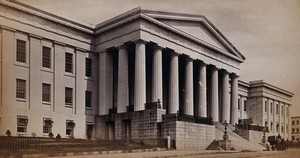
[231,74,238,125]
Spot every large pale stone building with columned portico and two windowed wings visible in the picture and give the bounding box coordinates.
[0,1,293,147]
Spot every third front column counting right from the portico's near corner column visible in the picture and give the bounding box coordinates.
[168,52,179,114]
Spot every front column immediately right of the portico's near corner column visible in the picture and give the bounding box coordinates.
[152,46,163,104]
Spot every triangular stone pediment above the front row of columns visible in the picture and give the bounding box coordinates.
[142,10,245,61]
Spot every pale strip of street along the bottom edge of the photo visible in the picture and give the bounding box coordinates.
[50,149,300,158]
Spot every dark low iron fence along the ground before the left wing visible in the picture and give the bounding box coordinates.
[0,136,167,151]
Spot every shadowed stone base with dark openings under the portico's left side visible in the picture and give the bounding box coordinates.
[95,109,166,140]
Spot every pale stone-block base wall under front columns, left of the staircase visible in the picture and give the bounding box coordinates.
[163,121,215,149]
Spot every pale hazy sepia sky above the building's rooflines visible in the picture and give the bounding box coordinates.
[18,0,300,116]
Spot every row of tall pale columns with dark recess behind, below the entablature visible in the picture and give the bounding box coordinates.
[99,39,244,124]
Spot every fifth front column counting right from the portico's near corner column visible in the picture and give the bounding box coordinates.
[195,63,207,117]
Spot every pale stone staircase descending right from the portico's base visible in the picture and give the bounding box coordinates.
[215,123,264,151]
